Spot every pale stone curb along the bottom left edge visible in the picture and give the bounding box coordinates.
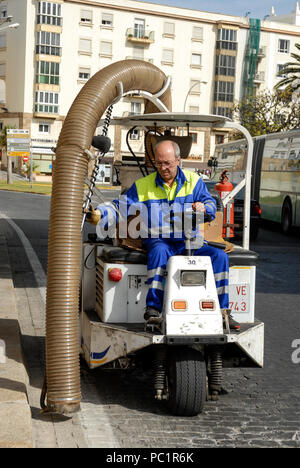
[0,235,34,448]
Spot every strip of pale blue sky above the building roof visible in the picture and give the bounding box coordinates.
[141,0,300,19]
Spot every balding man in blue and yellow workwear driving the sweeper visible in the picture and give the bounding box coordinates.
[87,140,240,330]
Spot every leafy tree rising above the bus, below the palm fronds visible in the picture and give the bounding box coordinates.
[233,90,300,139]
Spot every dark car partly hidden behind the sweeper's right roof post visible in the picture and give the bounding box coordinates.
[204,179,261,241]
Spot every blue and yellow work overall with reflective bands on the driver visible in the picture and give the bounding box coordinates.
[98,167,229,311]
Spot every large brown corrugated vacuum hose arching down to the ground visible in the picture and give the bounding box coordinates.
[46,60,171,414]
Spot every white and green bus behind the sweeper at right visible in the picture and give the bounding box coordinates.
[212,130,300,233]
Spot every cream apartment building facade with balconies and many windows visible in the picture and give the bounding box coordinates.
[0,0,300,182]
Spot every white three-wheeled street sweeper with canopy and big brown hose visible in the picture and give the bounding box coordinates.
[42,61,264,416]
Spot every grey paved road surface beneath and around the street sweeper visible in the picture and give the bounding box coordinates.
[0,192,300,449]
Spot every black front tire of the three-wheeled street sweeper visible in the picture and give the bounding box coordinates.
[167,347,206,416]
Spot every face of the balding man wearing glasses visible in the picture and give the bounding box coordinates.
[155,141,180,182]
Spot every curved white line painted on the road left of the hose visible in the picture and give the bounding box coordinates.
[0,213,47,304]
